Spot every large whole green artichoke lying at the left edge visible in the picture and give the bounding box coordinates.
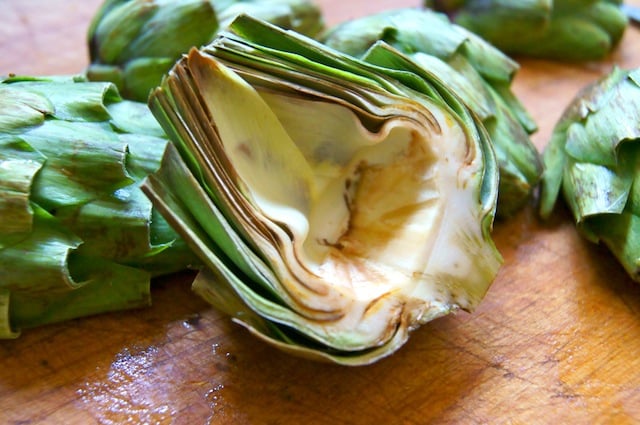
[0,77,197,338]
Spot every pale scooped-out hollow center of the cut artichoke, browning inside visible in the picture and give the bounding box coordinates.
[190,48,482,308]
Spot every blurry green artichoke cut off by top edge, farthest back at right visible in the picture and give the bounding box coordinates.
[425,0,627,61]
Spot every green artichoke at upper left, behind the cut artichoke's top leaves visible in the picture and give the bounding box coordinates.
[86,0,323,102]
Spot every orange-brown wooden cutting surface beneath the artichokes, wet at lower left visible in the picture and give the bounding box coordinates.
[0,0,640,424]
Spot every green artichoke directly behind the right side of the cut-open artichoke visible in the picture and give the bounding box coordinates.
[322,9,542,216]
